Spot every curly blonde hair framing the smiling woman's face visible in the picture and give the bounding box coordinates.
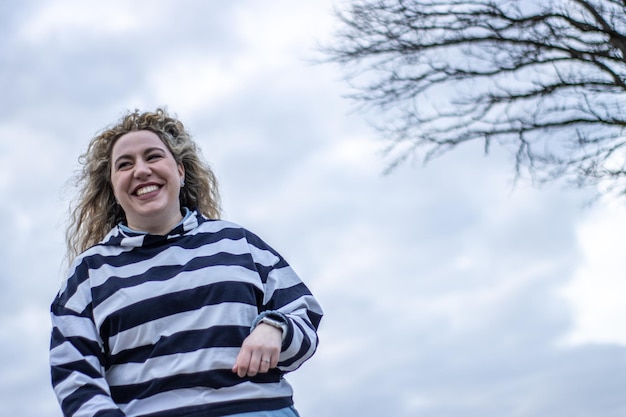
[65,108,221,261]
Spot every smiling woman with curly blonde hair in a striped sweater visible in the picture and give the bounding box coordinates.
[50,109,322,417]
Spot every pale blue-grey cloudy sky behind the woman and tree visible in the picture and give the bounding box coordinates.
[0,0,626,417]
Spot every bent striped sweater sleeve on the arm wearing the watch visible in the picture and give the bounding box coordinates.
[244,231,323,372]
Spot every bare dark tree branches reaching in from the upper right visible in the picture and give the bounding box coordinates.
[322,0,626,193]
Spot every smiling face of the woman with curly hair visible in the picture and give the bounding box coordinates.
[111,130,185,234]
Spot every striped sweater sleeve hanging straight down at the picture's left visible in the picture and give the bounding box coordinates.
[50,266,125,417]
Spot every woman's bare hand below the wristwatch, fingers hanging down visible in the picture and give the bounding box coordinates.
[232,323,283,377]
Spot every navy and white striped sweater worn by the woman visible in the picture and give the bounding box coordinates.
[50,212,322,417]
